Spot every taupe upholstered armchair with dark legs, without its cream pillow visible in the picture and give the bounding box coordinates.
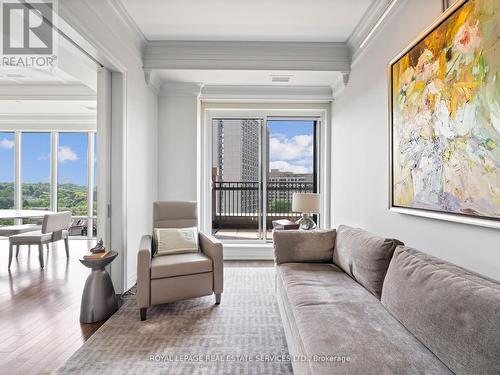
[137,201,224,320]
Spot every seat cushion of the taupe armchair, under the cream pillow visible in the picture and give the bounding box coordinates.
[151,253,212,279]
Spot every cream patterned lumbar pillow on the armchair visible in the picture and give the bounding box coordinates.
[154,228,199,256]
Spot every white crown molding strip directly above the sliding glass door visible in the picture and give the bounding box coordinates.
[200,85,333,101]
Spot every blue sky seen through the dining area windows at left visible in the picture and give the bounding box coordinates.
[0,133,87,185]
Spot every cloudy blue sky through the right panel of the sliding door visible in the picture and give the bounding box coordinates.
[267,120,314,173]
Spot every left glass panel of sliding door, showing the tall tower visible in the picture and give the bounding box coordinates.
[212,118,263,240]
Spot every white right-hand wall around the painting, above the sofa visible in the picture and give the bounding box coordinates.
[332,0,500,280]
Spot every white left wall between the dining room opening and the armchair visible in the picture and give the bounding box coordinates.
[59,0,158,292]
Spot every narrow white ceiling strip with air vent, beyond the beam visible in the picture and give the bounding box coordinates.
[157,69,339,86]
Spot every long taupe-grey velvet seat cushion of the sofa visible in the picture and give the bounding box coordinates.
[276,263,451,375]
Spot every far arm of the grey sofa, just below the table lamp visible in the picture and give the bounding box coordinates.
[273,229,336,264]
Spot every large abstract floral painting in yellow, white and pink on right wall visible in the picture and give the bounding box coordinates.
[389,0,500,226]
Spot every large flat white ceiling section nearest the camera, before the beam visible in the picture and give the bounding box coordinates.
[119,0,379,42]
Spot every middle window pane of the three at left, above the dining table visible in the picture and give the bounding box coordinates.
[21,133,51,210]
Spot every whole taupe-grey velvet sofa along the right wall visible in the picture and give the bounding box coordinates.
[273,226,500,375]
